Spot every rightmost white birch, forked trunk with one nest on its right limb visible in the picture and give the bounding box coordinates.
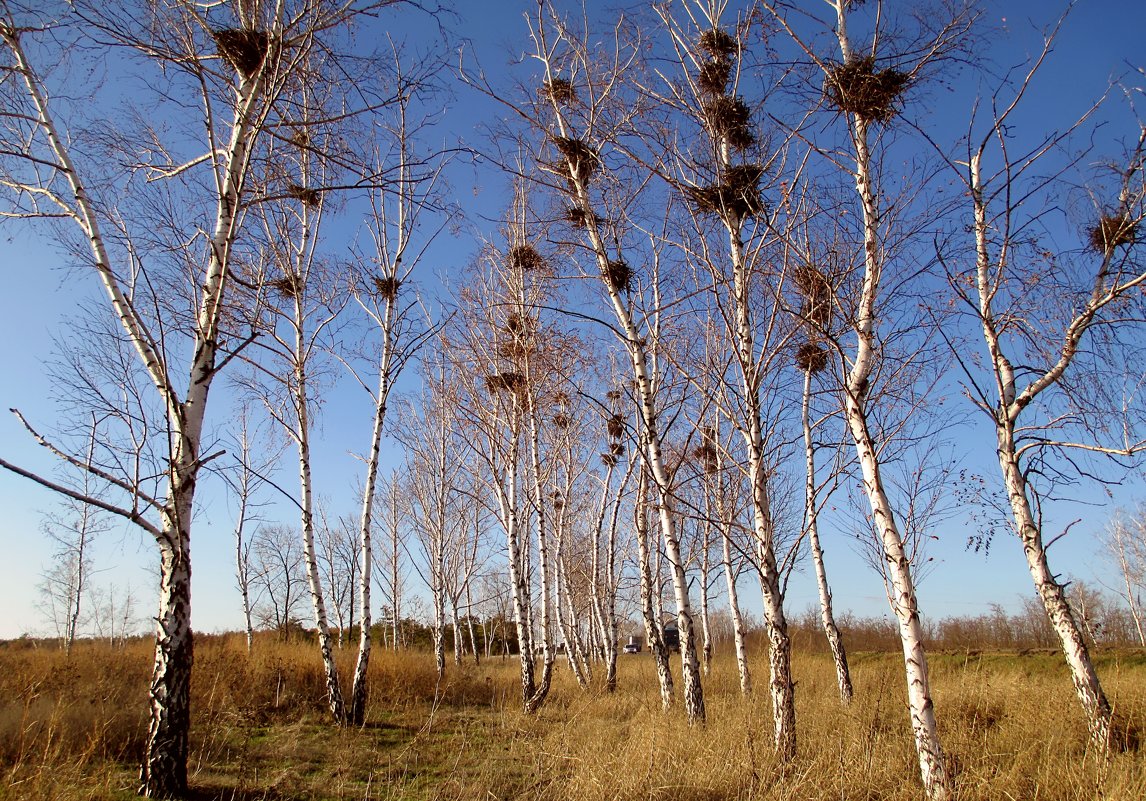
[949,29,1146,749]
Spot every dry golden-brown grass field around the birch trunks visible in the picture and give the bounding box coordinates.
[0,637,1146,801]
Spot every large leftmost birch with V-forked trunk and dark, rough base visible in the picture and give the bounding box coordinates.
[0,0,387,796]
